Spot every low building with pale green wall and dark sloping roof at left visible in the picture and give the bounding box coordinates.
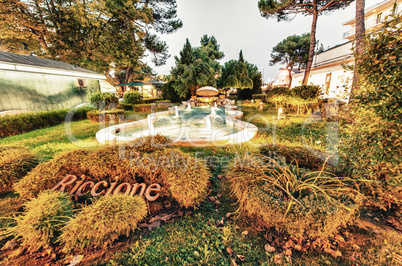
[0,51,106,112]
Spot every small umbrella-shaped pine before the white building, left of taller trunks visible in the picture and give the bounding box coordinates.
[270,33,310,88]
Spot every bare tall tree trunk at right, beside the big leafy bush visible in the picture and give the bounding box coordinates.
[349,0,366,103]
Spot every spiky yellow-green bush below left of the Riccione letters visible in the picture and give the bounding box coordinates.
[7,191,73,250]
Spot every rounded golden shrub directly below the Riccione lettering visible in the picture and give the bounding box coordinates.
[60,194,147,250]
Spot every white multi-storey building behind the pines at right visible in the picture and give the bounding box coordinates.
[291,0,402,101]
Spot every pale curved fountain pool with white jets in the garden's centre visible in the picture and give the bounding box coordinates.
[96,105,258,146]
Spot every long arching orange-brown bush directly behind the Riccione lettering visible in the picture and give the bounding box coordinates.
[14,145,210,210]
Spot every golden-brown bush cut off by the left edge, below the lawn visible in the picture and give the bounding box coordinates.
[0,146,39,192]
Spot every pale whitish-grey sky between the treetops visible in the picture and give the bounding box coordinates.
[145,0,381,82]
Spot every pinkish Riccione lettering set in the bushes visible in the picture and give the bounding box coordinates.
[52,175,161,201]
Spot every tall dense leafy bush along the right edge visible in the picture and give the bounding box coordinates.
[340,14,402,215]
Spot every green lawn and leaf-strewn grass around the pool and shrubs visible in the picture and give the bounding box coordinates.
[0,104,402,265]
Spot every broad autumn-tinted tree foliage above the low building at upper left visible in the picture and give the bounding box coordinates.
[0,0,182,71]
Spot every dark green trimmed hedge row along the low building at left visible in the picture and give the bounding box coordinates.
[0,107,93,138]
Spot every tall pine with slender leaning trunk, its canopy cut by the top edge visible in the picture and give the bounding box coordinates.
[258,0,353,85]
